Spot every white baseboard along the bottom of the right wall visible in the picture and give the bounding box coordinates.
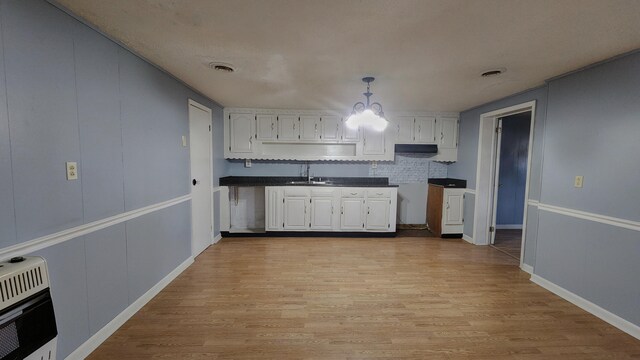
[531,274,640,340]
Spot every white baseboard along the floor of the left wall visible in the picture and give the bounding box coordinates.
[65,257,193,360]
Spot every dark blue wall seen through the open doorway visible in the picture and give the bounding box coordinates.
[496,112,531,225]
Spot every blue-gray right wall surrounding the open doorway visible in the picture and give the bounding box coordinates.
[449,52,640,326]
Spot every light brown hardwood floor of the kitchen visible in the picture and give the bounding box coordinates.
[89,237,640,360]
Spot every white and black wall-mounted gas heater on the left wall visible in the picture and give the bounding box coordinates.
[0,257,58,360]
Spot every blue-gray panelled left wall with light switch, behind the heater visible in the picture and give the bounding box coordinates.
[0,0,227,359]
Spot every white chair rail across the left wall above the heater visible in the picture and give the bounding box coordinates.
[0,195,191,259]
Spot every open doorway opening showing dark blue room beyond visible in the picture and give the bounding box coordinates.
[491,111,531,260]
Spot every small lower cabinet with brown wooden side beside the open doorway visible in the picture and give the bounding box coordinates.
[427,184,464,236]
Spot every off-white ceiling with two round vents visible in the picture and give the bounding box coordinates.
[58,0,640,111]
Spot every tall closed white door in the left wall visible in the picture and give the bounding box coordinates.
[189,100,213,256]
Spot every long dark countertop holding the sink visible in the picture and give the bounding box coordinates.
[219,176,398,187]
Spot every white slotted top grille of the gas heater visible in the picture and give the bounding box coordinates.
[0,257,49,309]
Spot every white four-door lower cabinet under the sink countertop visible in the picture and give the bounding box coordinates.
[265,186,398,232]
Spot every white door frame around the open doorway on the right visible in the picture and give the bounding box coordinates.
[473,100,536,267]
